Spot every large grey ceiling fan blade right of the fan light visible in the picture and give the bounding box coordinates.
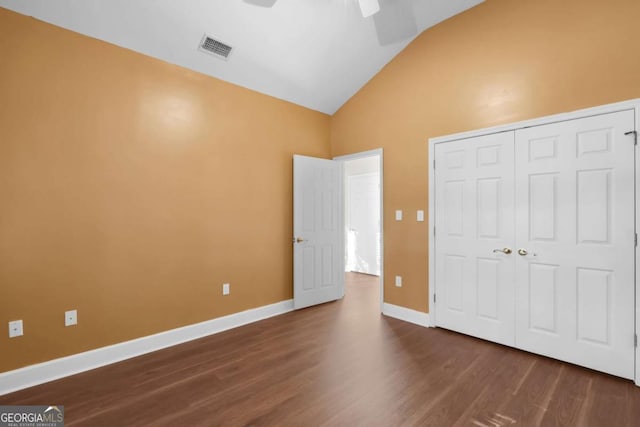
[373,0,418,46]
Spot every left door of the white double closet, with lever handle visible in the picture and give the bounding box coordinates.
[435,132,515,346]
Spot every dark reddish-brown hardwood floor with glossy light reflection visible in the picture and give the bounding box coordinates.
[0,274,640,427]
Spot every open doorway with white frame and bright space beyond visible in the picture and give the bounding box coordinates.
[334,149,384,312]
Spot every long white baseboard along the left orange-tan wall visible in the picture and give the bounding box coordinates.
[0,300,293,396]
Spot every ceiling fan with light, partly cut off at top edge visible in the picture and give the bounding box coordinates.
[244,0,418,46]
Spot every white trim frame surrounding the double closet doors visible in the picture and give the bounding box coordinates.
[427,98,640,386]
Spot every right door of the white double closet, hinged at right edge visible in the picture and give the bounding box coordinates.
[516,111,635,378]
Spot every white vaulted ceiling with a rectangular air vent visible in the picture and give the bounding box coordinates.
[0,0,484,114]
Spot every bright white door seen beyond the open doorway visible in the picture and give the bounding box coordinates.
[347,173,380,276]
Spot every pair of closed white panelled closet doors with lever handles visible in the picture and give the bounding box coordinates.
[435,110,635,378]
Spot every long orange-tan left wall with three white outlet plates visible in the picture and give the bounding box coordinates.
[0,9,330,372]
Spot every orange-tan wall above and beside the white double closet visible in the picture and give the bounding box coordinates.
[331,0,640,312]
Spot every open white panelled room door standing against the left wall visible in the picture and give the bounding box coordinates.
[293,155,344,309]
